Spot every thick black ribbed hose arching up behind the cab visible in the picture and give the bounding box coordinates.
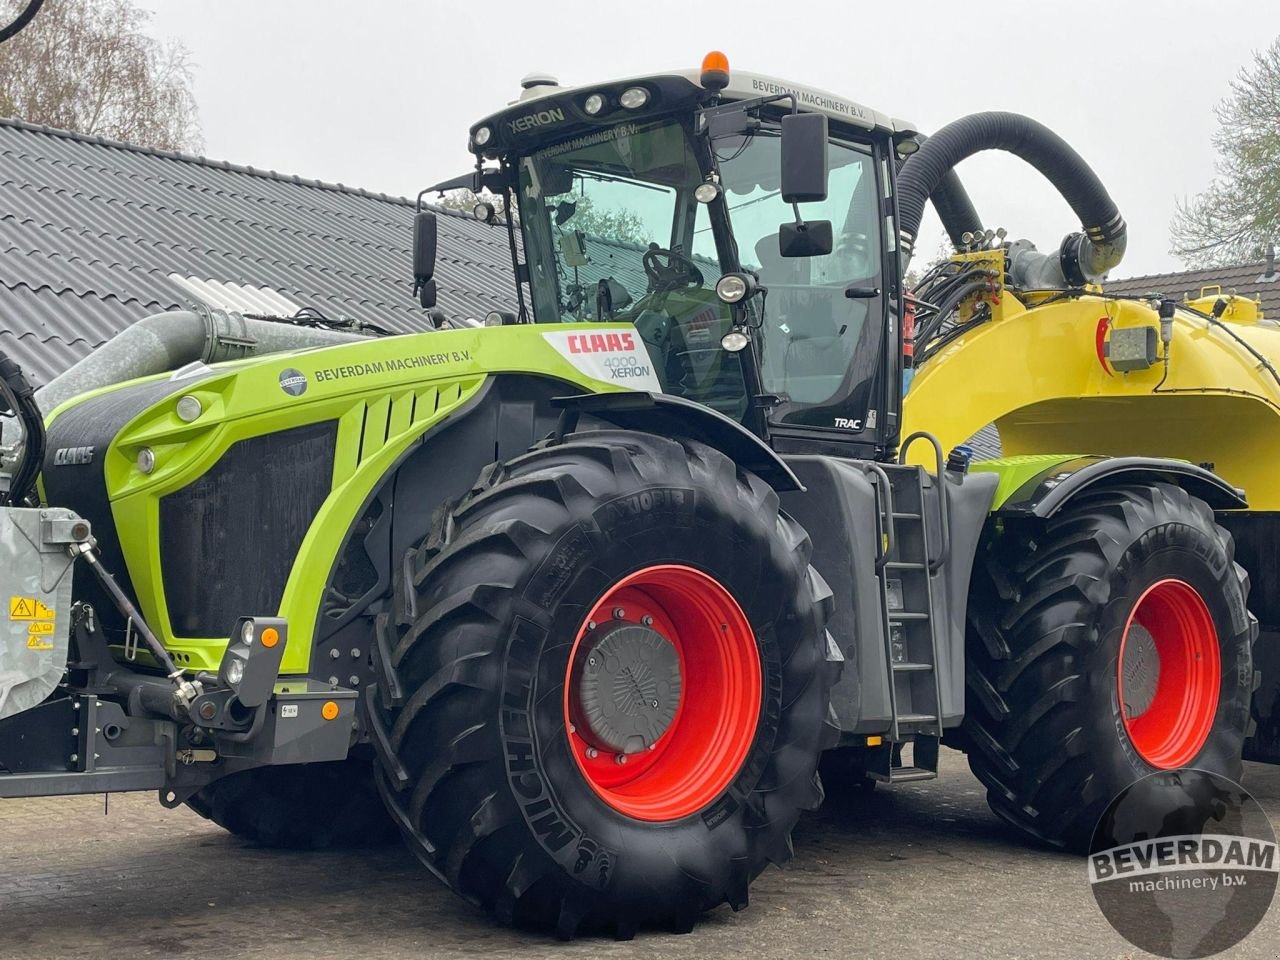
[897,113,1126,284]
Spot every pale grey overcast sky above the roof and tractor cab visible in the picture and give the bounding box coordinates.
[140,0,1280,276]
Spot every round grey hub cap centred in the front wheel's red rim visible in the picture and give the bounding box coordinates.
[579,623,681,754]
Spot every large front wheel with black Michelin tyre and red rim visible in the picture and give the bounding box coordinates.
[375,430,840,938]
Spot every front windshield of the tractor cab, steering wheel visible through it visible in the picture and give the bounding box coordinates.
[517,120,746,419]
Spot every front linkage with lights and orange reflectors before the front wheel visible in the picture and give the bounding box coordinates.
[0,527,356,806]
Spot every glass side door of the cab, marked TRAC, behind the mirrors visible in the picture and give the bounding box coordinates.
[694,125,882,430]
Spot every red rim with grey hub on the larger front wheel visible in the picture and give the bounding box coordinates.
[563,563,762,822]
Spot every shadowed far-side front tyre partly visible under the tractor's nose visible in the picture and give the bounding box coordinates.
[187,750,397,850]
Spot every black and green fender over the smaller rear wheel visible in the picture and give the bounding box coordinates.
[974,457,1249,518]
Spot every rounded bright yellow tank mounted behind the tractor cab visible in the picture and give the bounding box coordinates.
[904,251,1280,511]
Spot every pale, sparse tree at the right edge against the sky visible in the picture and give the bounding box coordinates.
[1170,38,1280,266]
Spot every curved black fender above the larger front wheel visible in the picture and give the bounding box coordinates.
[552,392,804,493]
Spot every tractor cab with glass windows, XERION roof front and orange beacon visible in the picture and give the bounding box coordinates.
[419,54,910,458]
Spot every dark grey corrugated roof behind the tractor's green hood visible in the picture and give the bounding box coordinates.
[0,119,515,383]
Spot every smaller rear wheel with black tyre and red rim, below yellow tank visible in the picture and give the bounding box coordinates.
[963,483,1257,851]
